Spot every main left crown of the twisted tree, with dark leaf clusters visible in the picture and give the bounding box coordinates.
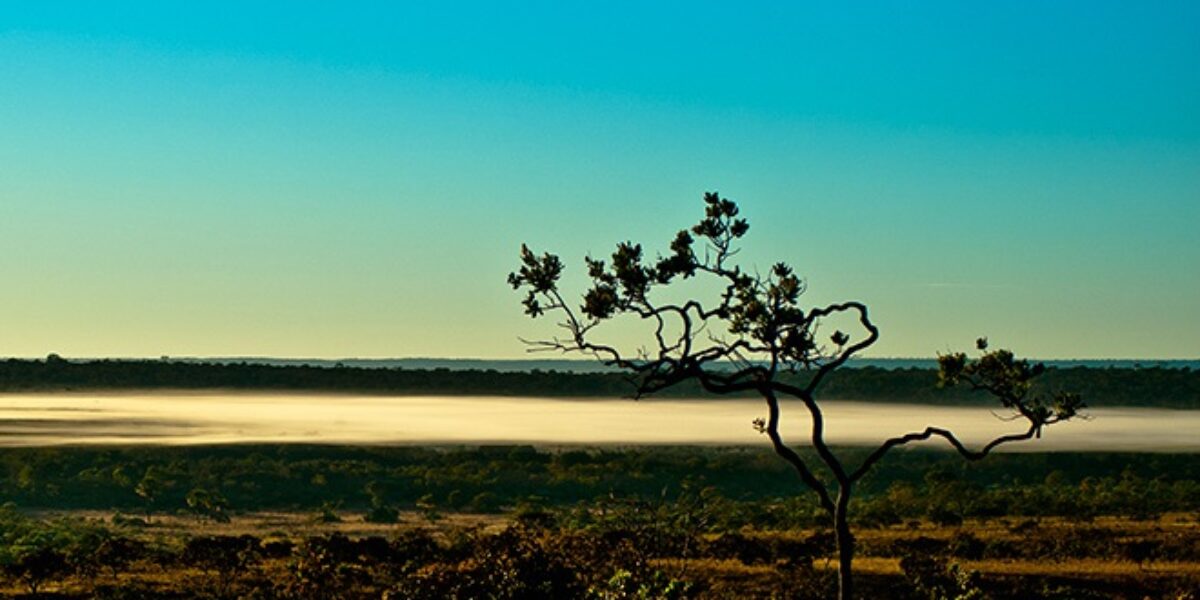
[508,192,876,384]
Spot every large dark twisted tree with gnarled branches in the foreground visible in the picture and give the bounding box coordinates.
[508,193,1082,599]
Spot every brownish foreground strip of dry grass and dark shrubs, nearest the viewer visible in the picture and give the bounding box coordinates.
[0,500,1200,600]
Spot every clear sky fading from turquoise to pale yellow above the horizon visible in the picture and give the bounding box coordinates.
[0,0,1200,359]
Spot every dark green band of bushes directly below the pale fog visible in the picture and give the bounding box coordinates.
[0,445,1200,520]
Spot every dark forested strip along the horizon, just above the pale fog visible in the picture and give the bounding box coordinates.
[0,354,1200,408]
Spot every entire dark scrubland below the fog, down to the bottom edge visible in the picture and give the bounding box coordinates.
[0,445,1200,599]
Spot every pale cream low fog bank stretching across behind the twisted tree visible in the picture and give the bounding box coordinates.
[0,392,1200,452]
